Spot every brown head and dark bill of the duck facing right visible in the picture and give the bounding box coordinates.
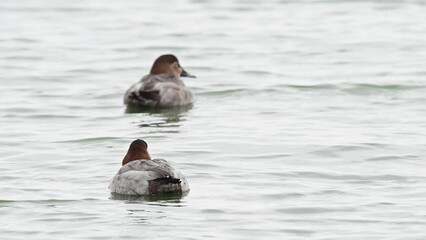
[150,54,195,78]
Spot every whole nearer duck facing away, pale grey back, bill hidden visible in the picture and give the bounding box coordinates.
[109,139,189,196]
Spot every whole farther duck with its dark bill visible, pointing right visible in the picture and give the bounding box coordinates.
[124,54,195,108]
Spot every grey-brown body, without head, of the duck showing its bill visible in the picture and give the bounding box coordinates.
[124,74,194,107]
